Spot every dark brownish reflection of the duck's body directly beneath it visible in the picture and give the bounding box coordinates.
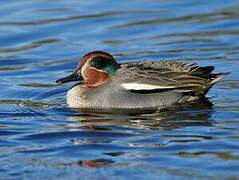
[69,99,213,131]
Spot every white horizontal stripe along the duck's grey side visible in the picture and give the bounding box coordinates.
[121,83,175,91]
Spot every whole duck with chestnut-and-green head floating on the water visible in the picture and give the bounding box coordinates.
[56,51,228,111]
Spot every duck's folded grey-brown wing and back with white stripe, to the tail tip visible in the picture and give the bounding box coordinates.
[117,61,225,96]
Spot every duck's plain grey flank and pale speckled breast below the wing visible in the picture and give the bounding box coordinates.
[66,72,182,110]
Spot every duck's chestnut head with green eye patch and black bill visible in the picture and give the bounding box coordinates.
[56,51,120,88]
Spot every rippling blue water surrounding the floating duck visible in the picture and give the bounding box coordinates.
[0,0,239,179]
